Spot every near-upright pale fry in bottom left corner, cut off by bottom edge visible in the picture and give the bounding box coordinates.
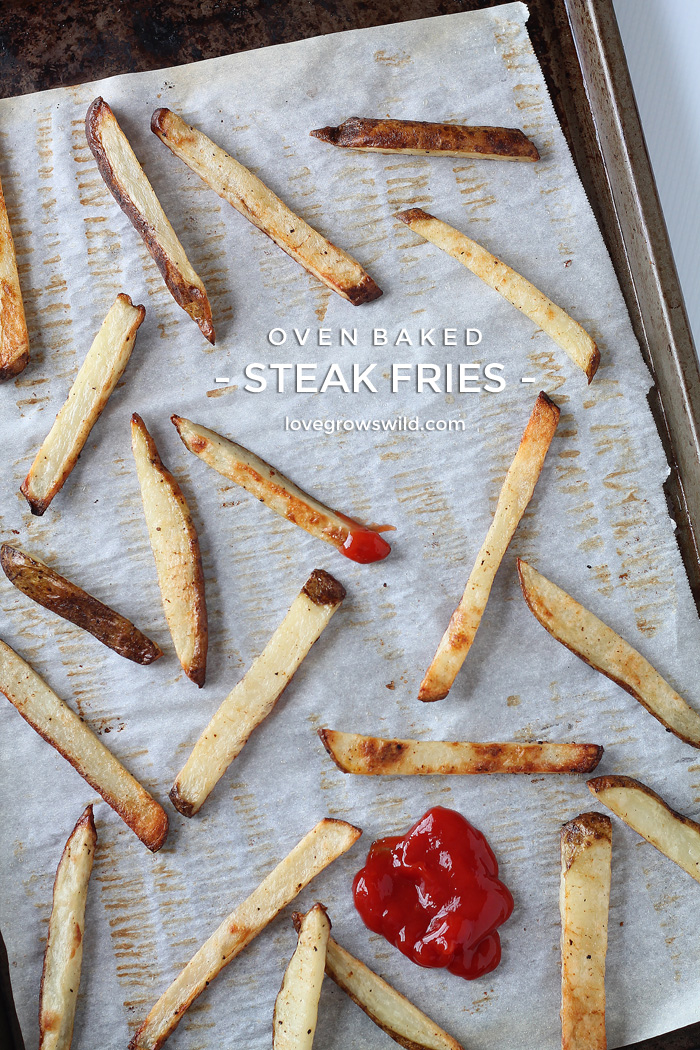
[39,805,98,1050]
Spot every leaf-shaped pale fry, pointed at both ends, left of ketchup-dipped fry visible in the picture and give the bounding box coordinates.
[131,413,209,689]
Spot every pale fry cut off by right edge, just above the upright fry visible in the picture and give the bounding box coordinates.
[588,776,700,882]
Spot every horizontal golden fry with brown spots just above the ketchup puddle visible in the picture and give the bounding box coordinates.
[318,729,602,776]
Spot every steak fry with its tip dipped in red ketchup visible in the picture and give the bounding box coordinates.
[170,416,391,563]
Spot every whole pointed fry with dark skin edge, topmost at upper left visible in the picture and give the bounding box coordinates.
[85,99,214,343]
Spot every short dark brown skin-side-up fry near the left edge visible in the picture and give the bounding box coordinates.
[0,543,163,664]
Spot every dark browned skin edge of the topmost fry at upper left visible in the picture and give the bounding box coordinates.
[85,97,215,345]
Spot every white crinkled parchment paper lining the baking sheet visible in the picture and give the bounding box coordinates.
[0,3,700,1050]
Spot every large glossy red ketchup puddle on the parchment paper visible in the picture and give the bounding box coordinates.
[353,805,513,981]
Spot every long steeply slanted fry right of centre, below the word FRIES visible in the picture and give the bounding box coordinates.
[418,392,559,700]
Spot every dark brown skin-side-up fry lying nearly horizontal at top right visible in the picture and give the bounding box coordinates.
[310,117,539,161]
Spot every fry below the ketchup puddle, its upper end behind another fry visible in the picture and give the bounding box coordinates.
[325,937,462,1050]
